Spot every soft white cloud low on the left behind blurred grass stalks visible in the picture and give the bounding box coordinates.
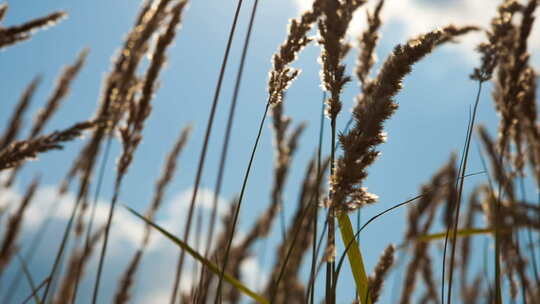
[0,180,262,303]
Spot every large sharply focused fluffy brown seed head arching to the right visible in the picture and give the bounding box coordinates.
[330,27,476,211]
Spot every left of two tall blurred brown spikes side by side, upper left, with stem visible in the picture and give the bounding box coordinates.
[39,1,179,304]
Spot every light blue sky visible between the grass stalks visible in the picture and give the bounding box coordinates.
[0,0,540,303]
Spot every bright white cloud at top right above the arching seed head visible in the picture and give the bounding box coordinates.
[296,0,540,66]
